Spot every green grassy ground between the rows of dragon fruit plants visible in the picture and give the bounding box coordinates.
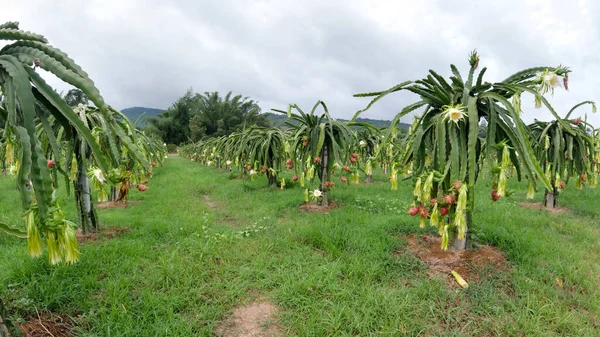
[0,157,600,336]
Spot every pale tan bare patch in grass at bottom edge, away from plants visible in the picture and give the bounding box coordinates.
[215,300,282,337]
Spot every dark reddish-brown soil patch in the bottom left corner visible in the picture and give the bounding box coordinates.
[15,312,75,337]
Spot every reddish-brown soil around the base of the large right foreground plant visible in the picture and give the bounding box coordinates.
[406,234,510,287]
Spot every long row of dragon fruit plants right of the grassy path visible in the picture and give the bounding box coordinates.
[179,51,600,249]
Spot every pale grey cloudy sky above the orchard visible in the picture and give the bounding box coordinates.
[0,0,600,126]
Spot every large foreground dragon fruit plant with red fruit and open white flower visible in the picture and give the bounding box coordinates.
[352,51,569,250]
